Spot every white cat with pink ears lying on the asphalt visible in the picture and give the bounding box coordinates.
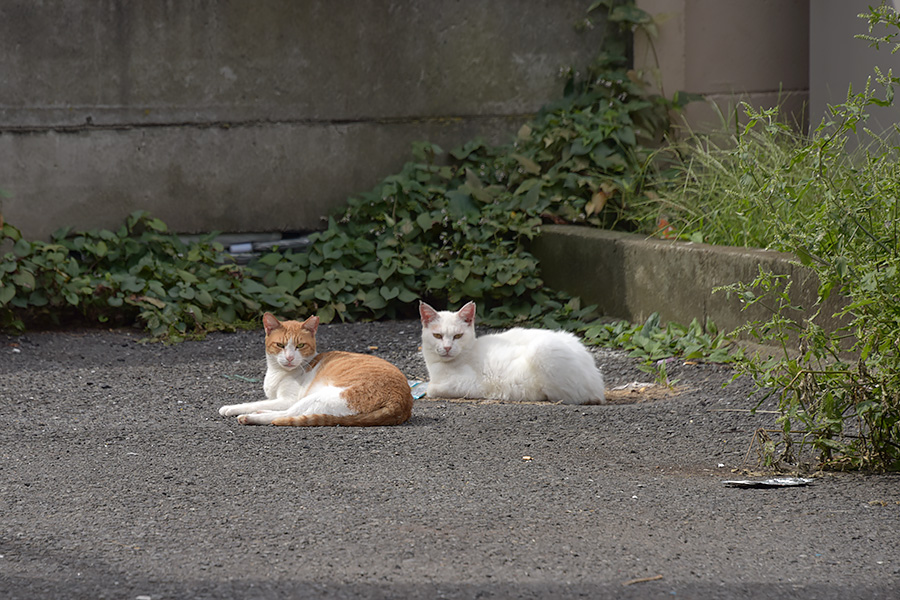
[419,302,606,404]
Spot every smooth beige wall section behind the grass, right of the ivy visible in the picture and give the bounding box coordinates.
[635,0,812,131]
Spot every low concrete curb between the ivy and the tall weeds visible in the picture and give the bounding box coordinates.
[530,225,846,338]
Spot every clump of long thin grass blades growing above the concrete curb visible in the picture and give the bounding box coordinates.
[634,105,820,250]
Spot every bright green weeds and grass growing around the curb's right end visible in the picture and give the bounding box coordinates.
[659,4,900,470]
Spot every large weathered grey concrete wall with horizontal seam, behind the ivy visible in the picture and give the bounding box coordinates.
[0,0,601,238]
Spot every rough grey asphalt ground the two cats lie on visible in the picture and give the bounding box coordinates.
[0,321,900,600]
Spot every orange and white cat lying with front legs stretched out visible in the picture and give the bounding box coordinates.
[219,313,413,427]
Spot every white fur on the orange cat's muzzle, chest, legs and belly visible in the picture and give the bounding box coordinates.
[219,344,356,425]
